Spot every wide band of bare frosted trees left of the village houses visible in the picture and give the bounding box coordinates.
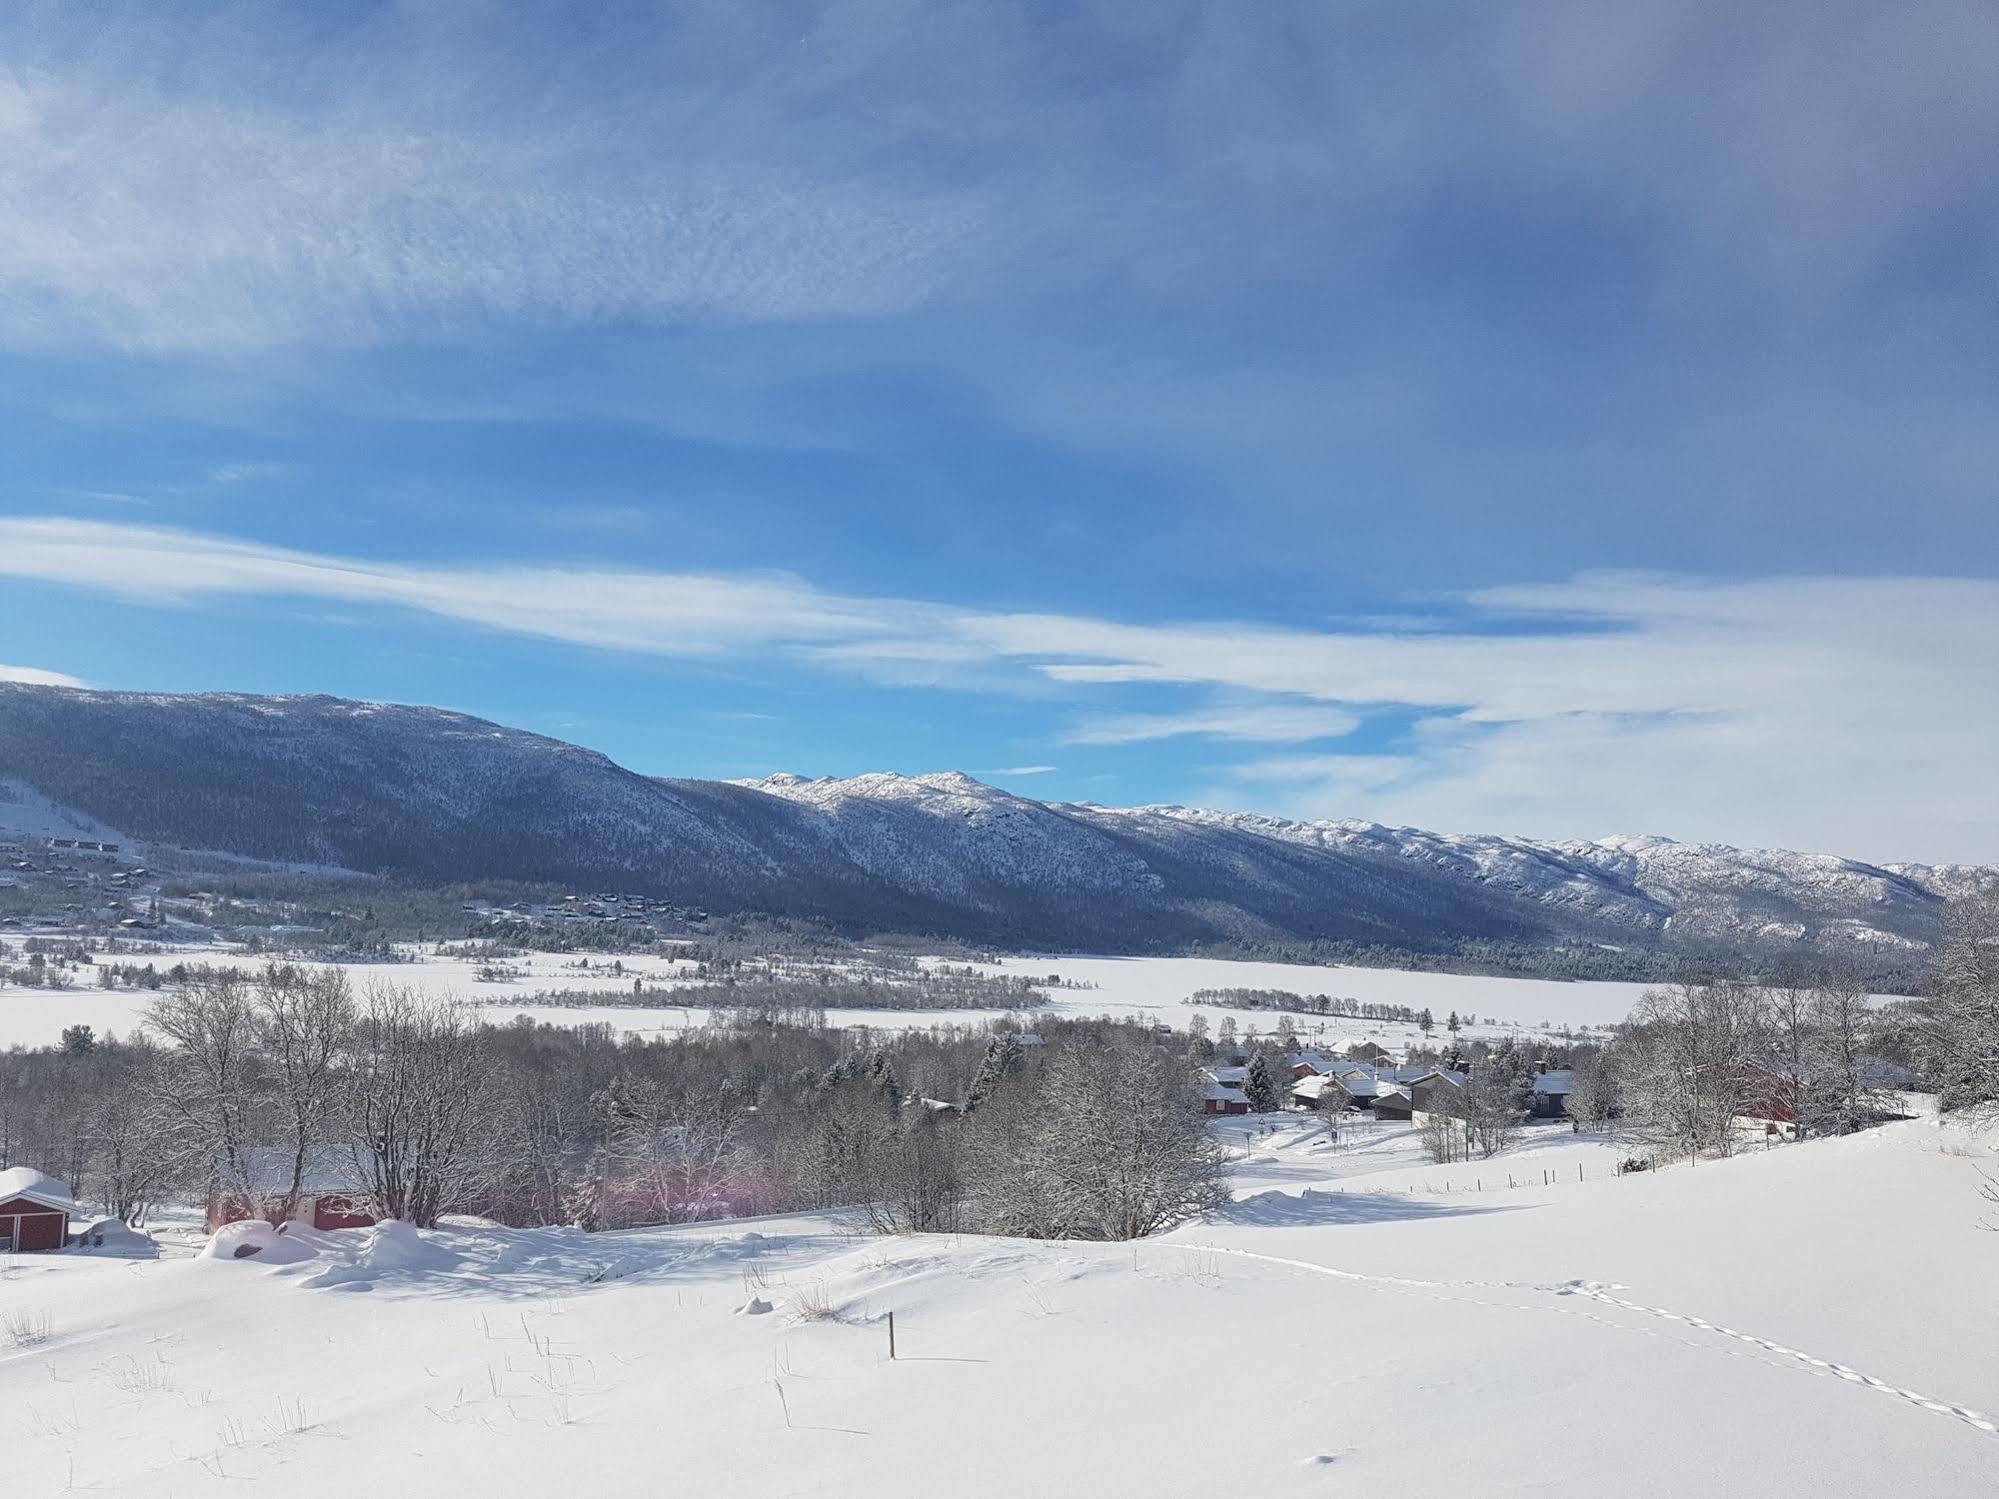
[0,963,1221,1237]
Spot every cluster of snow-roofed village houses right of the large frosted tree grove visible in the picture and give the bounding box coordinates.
[1201,1041,1573,1123]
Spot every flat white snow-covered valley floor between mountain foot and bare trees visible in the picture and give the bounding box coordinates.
[0,947,1645,1047]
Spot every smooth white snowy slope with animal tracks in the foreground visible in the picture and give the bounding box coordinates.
[0,1121,1999,1499]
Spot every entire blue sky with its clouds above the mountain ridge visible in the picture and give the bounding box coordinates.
[0,0,1999,861]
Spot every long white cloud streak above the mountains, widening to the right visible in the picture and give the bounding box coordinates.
[0,520,1999,861]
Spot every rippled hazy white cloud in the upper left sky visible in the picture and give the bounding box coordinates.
[0,10,984,354]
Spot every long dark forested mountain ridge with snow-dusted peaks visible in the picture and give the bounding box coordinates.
[0,684,1999,961]
